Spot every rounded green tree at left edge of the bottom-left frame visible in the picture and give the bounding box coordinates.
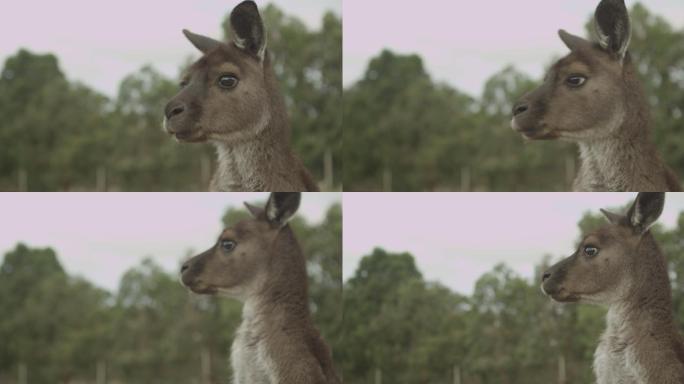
[0,244,111,382]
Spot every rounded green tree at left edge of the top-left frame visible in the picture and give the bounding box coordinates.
[0,49,107,190]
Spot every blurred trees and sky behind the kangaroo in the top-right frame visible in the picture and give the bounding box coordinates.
[343,0,684,191]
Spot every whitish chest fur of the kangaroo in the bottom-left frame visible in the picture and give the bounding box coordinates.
[230,320,275,384]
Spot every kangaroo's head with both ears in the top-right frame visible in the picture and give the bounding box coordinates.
[511,0,634,141]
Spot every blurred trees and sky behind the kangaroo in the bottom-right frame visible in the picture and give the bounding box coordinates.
[336,193,684,384]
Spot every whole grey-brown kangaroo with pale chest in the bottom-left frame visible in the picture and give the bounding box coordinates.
[181,192,341,384]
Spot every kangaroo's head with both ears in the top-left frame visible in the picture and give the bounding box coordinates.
[164,1,272,144]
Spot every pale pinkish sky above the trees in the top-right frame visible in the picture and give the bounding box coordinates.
[343,0,684,96]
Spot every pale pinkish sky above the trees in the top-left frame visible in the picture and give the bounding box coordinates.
[0,0,342,96]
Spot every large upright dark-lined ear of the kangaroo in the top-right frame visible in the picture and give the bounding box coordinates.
[594,0,632,61]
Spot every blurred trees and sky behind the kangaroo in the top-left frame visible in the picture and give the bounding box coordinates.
[0,0,342,191]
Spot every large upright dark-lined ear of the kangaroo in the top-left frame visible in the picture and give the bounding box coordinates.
[230,1,266,61]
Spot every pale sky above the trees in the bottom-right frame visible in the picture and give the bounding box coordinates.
[343,193,684,294]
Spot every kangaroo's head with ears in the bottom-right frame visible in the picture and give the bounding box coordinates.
[542,192,665,305]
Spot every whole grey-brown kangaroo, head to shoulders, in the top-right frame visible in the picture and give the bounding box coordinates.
[511,0,681,192]
